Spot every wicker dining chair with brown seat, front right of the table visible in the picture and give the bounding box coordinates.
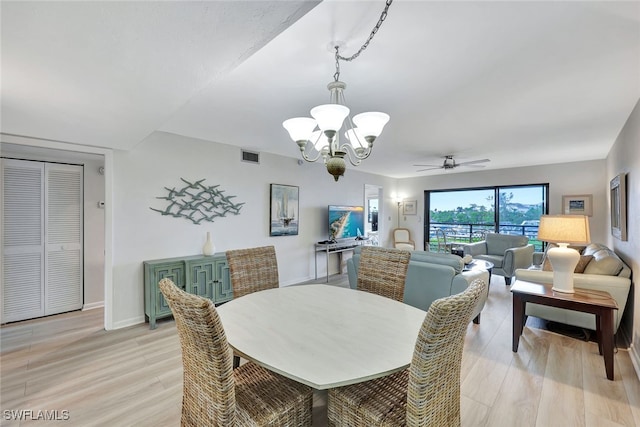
[328,279,487,427]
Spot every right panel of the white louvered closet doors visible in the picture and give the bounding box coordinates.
[44,164,83,315]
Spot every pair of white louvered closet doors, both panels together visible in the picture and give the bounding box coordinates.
[0,159,83,323]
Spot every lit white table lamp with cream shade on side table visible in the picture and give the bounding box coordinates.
[538,215,591,294]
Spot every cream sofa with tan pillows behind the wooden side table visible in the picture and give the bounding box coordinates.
[516,243,631,333]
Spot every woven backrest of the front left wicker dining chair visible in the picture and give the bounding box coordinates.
[159,279,236,426]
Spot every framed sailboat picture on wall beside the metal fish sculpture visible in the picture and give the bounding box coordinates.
[269,184,300,236]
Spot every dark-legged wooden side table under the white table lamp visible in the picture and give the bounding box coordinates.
[511,280,618,380]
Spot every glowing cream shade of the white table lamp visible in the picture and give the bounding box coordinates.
[538,215,591,245]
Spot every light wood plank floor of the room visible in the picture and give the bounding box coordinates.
[0,276,640,427]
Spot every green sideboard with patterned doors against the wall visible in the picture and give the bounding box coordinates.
[143,253,233,329]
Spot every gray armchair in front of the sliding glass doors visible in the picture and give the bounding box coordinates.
[460,233,534,286]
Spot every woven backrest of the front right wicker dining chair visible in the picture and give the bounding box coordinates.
[406,279,487,426]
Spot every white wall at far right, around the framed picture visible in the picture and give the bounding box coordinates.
[603,101,640,377]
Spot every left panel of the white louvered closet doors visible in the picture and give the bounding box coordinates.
[1,159,44,323]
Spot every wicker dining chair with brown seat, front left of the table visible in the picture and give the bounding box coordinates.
[159,279,313,427]
